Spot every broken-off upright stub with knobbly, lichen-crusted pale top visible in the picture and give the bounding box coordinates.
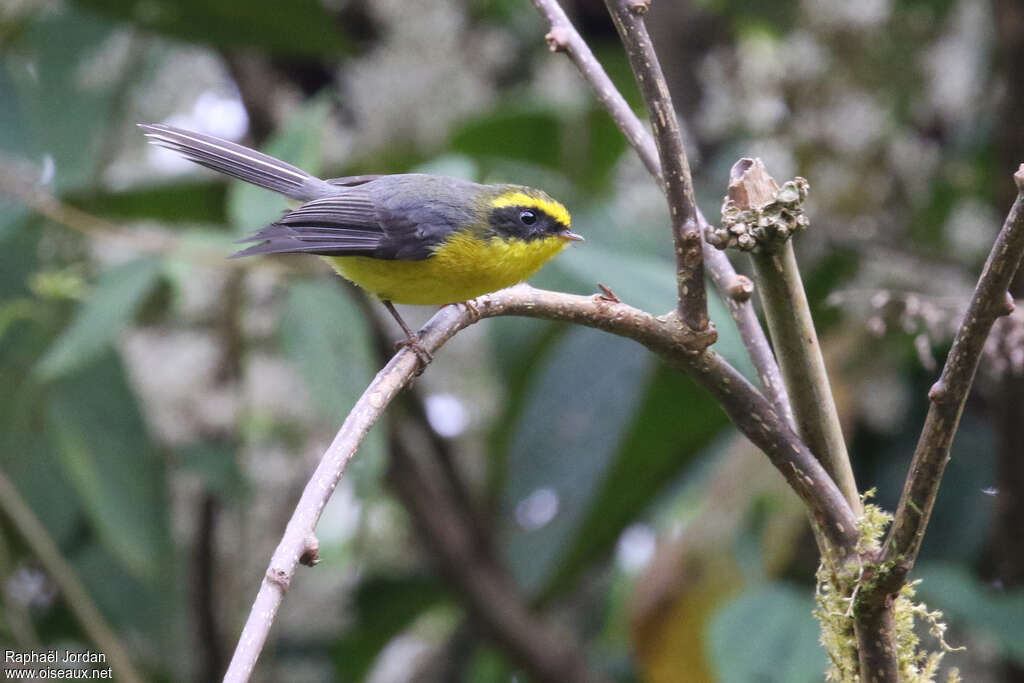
[707,159,860,514]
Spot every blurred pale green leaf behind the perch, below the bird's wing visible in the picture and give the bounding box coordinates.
[281,280,384,489]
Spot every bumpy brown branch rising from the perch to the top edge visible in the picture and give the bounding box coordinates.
[605,0,708,330]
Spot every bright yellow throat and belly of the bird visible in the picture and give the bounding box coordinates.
[324,233,567,305]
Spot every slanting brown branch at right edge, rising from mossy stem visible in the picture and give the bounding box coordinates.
[883,164,1024,570]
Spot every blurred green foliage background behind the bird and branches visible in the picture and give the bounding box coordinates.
[0,0,1024,683]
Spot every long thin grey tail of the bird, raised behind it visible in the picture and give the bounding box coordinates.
[138,123,340,202]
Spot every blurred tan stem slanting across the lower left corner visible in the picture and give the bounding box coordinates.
[0,472,144,683]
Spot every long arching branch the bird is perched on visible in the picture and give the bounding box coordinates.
[224,285,857,683]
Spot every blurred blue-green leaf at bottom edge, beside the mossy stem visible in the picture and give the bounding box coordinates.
[708,584,827,683]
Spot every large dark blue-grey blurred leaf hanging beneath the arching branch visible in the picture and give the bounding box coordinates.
[501,329,653,591]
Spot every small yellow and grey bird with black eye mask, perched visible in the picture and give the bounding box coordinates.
[138,124,584,367]
